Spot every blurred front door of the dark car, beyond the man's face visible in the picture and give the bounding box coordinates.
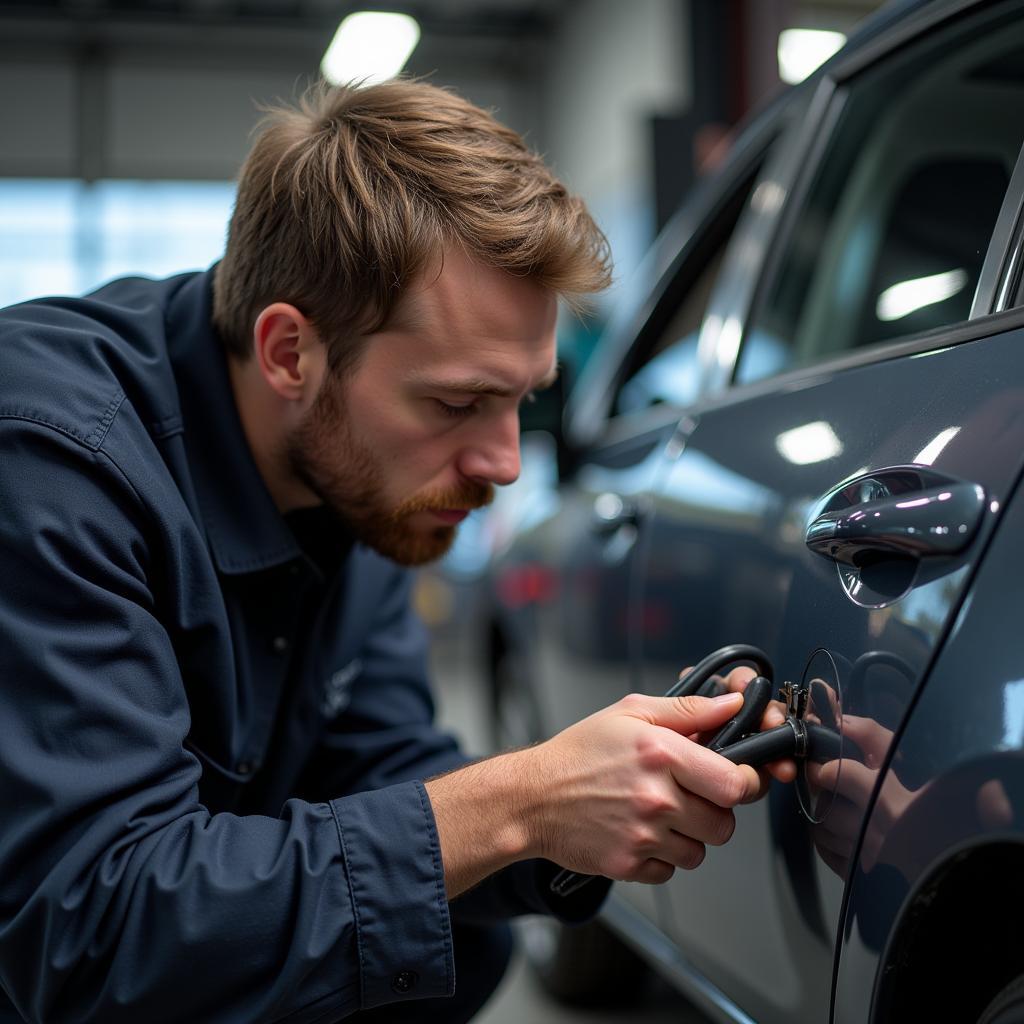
[486,99,791,937]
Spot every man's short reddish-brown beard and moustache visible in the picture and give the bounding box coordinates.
[286,379,495,565]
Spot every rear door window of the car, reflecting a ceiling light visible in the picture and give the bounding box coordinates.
[736,7,1024,382]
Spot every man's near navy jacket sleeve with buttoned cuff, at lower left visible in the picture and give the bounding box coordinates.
[0,418,454,1024]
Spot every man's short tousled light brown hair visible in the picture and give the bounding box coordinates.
[207,80,610,370]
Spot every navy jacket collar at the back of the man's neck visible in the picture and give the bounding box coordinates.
[166,267,302,574]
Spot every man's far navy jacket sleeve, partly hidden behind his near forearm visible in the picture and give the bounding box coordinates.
[290,569,610,924]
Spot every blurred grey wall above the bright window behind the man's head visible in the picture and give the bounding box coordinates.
[0,19,540,179]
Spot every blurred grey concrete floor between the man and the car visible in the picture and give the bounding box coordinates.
[432,641,708,1024]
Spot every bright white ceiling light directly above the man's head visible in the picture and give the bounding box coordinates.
[321,10,420,85]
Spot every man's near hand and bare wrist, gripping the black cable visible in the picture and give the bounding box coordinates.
[427,693,762,899]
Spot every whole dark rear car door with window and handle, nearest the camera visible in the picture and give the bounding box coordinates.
[631,3,1024,1024]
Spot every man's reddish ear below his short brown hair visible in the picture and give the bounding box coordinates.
[253,302,327,401]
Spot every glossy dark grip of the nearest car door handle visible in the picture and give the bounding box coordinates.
[806,482,985,567]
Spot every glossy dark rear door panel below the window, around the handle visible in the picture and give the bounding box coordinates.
[631,323,1024,1022]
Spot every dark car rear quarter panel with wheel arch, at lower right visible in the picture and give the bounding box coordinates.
[835,466,1024,1024]
